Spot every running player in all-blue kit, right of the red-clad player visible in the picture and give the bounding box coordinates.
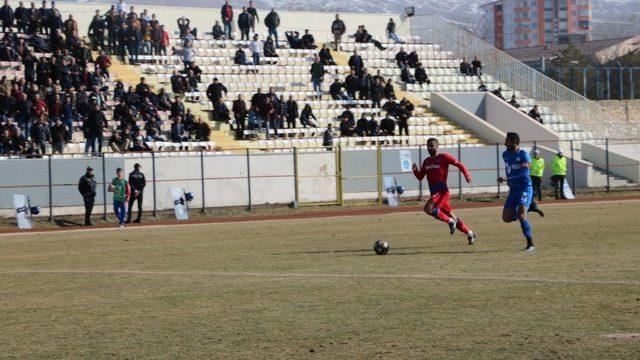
[498,132,542,252]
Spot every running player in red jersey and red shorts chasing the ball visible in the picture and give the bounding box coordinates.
[413,138,476,245]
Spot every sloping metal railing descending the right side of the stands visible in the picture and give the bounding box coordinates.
[411,15,640,139]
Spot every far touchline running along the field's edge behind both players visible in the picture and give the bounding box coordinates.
[0,199,640,238]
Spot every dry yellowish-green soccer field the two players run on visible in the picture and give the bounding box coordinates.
[0,201,640,359]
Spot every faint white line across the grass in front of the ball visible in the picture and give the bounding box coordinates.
[5,270,640,286]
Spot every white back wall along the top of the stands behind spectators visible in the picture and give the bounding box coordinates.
[15,0,408,42]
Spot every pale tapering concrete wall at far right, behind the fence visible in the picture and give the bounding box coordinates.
[582,143,640,183]
